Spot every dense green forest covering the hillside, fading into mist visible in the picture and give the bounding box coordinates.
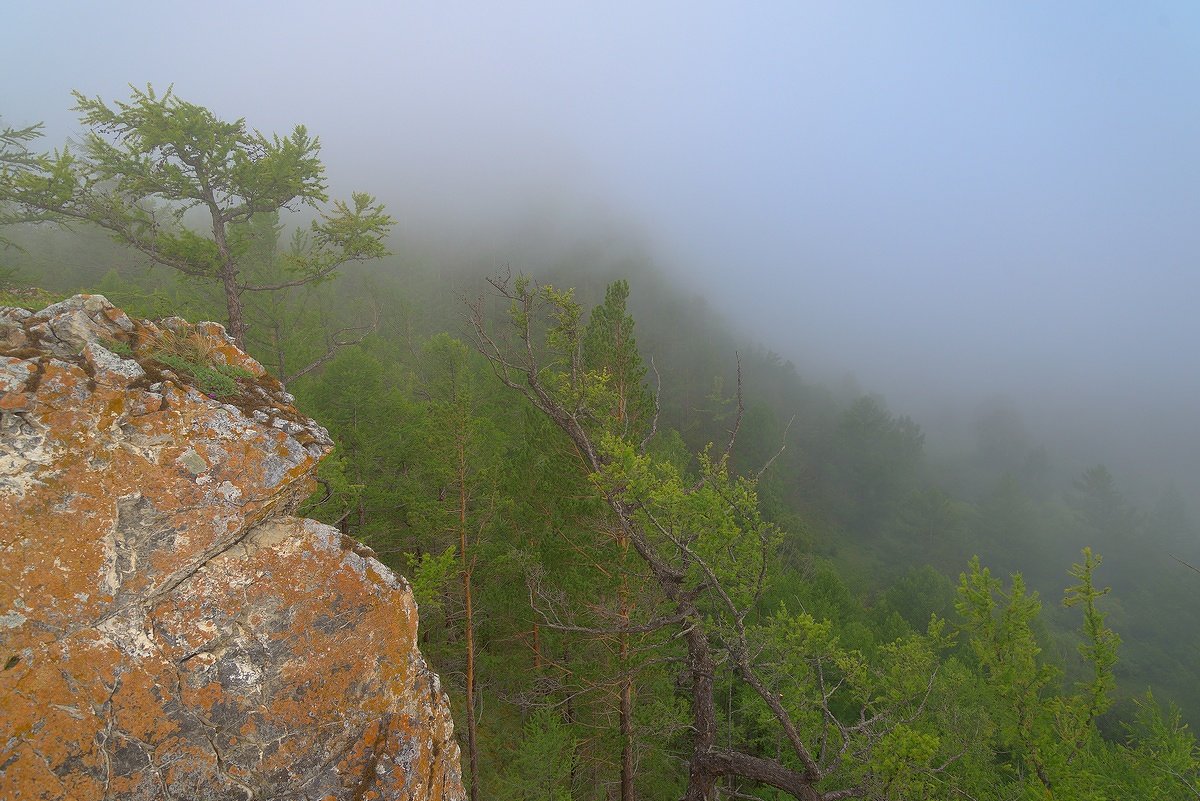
[0,92,1200,801]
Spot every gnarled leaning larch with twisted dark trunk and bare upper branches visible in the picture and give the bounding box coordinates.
[473,277,943,801]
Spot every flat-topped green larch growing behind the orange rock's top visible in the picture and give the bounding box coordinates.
[0,85,394,347]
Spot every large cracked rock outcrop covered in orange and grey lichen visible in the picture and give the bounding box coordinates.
[0,295,462,801]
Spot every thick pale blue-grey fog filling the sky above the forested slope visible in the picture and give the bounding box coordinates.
[7,1,1200,489]
